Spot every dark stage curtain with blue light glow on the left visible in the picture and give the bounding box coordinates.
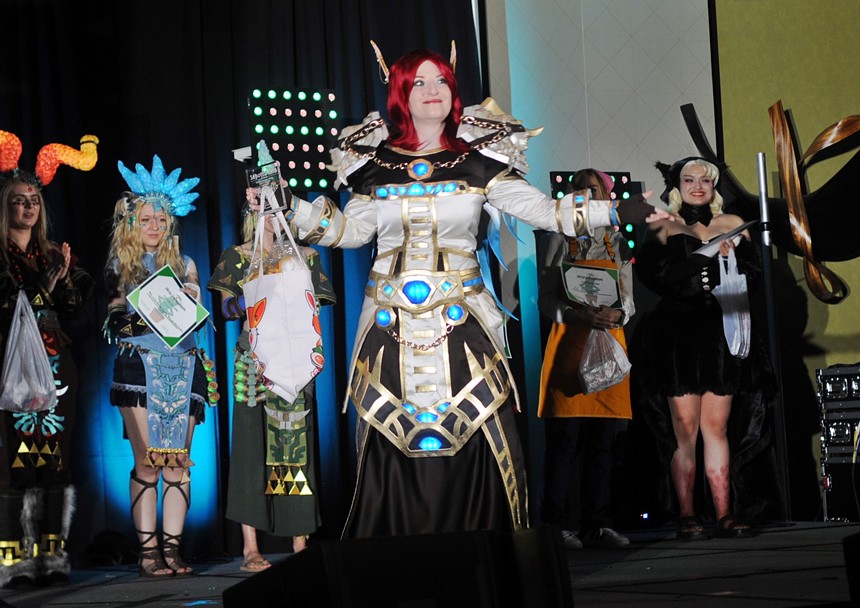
[0,0,483,556]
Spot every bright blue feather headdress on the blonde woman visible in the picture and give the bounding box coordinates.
[117,154,200,217]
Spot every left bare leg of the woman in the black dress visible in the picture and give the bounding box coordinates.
[669,395,702,517]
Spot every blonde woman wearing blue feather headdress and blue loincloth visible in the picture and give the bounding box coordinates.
[105,156,212,577]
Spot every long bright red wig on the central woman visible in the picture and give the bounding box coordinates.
[388,50,469,152]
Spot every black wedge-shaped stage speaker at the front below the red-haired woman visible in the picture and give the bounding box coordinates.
[223,527,573,608]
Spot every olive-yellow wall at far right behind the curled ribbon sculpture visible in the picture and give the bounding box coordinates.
[716,0,860,374]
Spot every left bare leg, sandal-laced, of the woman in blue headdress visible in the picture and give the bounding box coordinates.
[120,407,173,576]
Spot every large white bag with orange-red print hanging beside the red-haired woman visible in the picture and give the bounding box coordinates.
[242,188,323,403]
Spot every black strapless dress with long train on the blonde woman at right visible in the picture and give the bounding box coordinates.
[630,234,779,518]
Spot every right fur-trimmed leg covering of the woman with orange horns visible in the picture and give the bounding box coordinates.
[38,485,76,581]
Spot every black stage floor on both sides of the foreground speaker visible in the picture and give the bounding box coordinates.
[0,523,860,608]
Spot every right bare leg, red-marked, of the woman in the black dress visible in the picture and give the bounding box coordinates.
[701,393,732,521]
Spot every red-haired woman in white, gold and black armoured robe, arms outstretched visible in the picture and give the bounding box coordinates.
[266,44,665,537]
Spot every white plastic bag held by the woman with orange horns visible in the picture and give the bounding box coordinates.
[0,289,57,412]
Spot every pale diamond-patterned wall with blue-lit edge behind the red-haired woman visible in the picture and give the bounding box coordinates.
[487,0,714,486]
